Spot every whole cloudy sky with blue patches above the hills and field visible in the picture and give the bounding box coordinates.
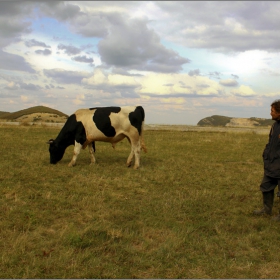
[0,1,280,125]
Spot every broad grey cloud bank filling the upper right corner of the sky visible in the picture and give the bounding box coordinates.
[156,1,280,53]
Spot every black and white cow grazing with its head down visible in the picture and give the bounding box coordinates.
[47,106,147,169]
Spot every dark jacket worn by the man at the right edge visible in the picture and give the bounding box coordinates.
[263,120,280,178]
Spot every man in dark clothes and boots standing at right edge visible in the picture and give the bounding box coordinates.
[253,100,280,221]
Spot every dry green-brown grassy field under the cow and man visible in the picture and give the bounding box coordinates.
[0,126,280,278]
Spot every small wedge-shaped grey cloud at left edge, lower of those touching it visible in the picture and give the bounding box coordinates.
[0,50,36,73]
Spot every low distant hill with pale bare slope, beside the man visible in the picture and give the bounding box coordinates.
[197,115,274,127]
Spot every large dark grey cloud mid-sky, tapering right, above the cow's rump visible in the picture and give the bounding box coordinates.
[98,15,190,72]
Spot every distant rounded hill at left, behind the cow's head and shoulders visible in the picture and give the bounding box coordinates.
[0,106,68,121]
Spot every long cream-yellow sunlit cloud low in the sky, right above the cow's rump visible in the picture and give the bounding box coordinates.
[82,69,224,98]
